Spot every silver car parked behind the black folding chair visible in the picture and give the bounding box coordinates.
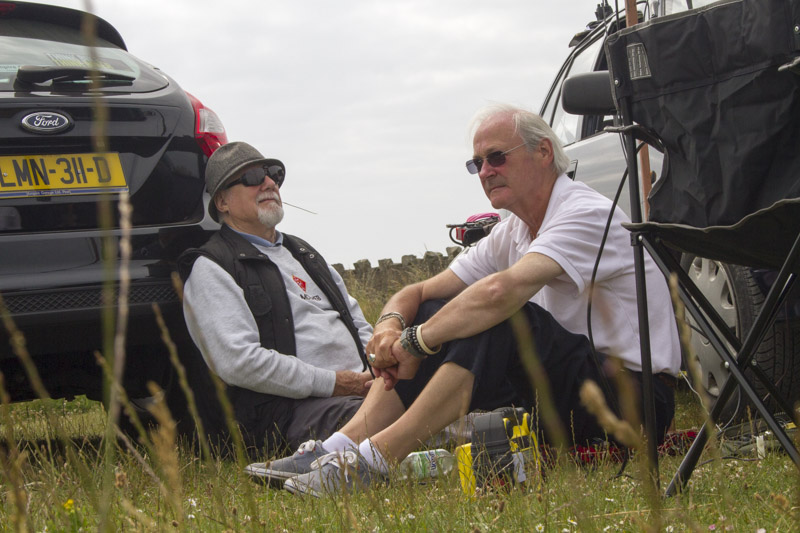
[540,0,800,420]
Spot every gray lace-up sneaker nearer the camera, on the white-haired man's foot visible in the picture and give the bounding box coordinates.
[283,450,386,498]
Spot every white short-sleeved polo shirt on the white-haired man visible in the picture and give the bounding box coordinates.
[450,175,680,375]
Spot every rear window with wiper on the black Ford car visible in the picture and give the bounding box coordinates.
[0,19,168,93]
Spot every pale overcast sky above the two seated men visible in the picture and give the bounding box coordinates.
[31,0,599,267]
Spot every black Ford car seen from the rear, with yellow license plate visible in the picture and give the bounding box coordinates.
[0,1,227,408]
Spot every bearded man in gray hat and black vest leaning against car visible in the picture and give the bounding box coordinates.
[179,142,372,455]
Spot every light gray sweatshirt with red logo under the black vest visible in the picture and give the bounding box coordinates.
[183,234,372,398]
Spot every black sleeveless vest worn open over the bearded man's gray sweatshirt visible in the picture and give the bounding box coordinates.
[178,225,368,450]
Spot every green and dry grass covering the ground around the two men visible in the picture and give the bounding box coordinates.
[0,266,800,533]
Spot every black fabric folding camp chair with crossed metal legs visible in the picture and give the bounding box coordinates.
[606,0,800,495]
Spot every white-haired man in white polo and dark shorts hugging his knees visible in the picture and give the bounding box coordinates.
[273,106,680,496]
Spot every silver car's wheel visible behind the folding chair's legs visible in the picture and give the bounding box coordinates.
[681,254,800,426]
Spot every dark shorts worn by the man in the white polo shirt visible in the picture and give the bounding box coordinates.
[395,300,674,443]
